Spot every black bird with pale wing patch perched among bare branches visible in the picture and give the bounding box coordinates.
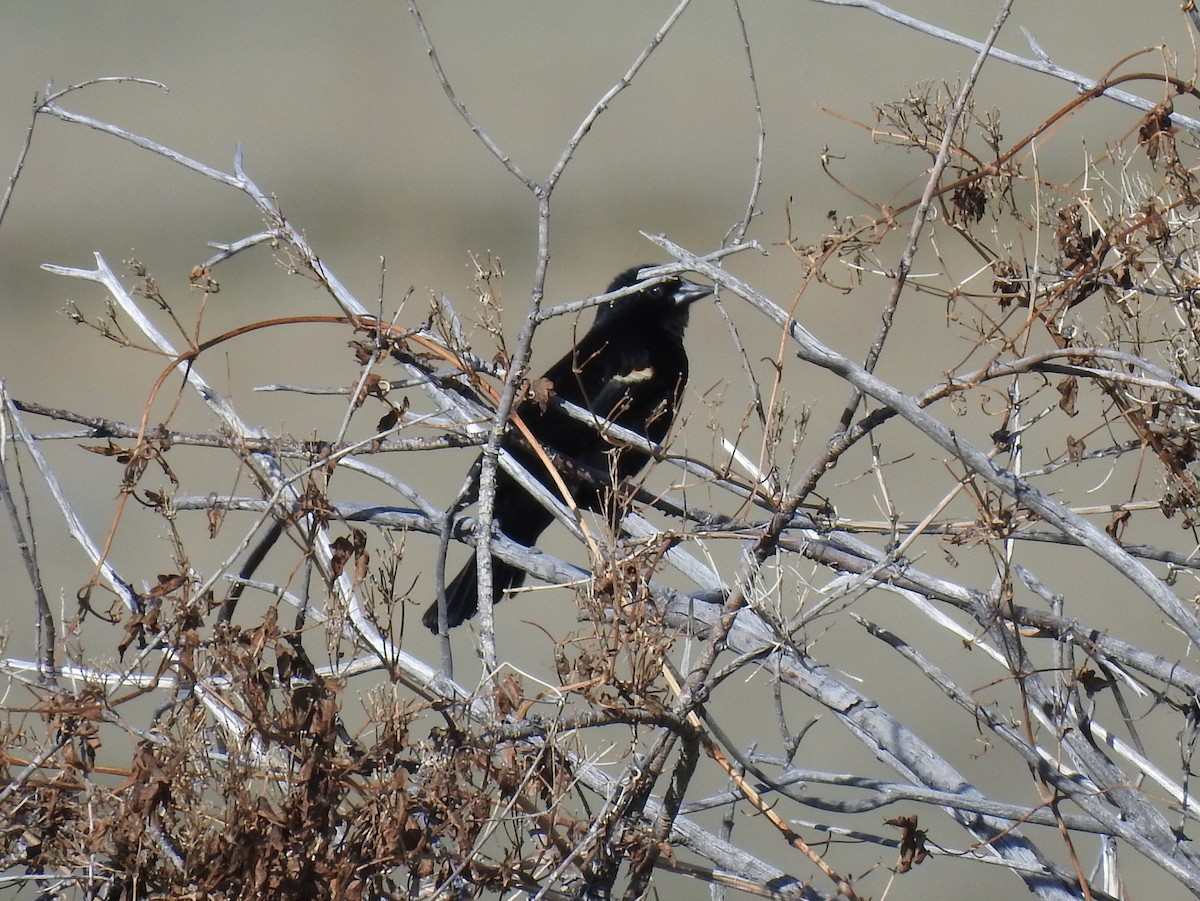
[421,264,713,632]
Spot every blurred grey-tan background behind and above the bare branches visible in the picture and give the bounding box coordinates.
[0,0,1193,899]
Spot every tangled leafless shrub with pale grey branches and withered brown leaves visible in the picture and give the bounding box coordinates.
[7,1,1200,899]
